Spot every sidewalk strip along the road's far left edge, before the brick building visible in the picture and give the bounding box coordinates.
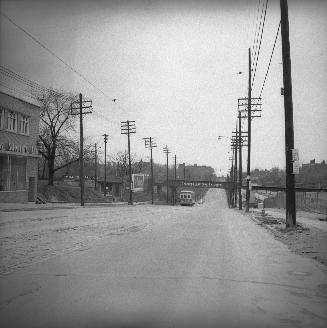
[0,202,131,212]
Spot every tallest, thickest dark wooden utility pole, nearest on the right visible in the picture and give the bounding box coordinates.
[280,0,296,227]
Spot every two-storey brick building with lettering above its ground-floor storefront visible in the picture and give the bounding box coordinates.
[0,91,40,203]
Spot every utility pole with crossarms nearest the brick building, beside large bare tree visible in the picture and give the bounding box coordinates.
[71,93,92,206]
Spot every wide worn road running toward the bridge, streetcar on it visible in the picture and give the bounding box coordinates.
[0,190,327,328]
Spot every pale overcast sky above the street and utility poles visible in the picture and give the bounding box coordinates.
[0,0,327,175]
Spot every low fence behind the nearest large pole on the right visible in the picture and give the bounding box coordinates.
[264,191,327,214]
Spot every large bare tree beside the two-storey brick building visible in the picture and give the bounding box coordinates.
[39,90,79,185]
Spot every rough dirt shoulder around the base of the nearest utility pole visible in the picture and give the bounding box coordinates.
[247,209,327,266]
